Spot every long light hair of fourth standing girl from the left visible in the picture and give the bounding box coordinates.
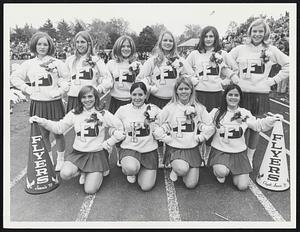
[151,31,179,67]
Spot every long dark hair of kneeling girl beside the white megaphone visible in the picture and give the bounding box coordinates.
[214,84,244,126]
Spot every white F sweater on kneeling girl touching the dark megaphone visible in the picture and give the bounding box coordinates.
[39,108,123,152]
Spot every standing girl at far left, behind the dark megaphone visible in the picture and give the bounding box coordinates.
[11,32,69,171]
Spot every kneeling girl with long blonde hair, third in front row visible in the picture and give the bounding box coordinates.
[154,77,214,188]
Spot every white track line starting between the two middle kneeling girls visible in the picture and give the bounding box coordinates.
[164,169,181,222]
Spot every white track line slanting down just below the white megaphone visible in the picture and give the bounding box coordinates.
[249,178,285,222]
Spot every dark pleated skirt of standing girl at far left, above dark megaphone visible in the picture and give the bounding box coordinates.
[30,99,65,121]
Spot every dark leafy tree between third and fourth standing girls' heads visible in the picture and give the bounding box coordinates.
[137,26,157,52]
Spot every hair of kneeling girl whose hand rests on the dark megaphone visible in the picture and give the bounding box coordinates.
[74,85,105,114]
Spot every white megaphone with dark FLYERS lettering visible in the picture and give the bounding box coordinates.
[256,117,290,191]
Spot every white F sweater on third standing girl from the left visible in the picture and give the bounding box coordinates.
[106,59,135,101]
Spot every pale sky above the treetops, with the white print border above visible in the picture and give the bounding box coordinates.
[4,3,296,36]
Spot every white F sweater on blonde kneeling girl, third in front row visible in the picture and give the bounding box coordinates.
[158,103,214,148]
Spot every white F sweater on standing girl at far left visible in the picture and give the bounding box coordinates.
[10,56,69,101]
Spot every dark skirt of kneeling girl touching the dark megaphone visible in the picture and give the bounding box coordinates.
[66,149,110,172]
